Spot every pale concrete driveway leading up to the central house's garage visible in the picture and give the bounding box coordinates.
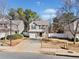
[7,39,41,53]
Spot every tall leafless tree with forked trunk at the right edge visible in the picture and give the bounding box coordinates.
[58,0,79,44]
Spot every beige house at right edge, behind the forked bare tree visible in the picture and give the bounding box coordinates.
[64,20,79,38]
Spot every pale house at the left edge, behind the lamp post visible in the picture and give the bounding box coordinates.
[0,17,24,38]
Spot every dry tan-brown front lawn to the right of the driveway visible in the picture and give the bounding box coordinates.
[42,38,79,52]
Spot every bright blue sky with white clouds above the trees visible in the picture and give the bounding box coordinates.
[4,0,61,19]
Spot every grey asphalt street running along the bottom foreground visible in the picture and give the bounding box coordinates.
[0,52,79,59]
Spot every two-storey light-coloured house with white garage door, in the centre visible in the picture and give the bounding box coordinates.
[29,20,49,39]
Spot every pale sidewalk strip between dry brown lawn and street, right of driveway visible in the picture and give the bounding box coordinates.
[40,48,79,57]
